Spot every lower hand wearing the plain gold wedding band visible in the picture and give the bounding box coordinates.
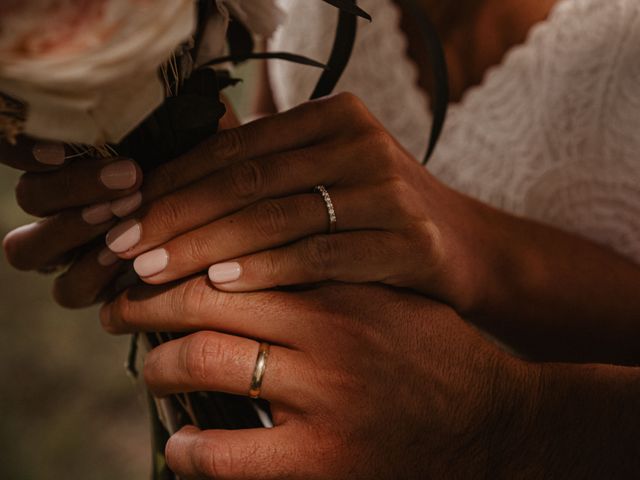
[101,277,537,479]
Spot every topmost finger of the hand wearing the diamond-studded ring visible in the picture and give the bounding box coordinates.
[143,94,372,199]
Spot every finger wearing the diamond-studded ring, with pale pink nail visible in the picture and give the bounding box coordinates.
[134,188,396,284]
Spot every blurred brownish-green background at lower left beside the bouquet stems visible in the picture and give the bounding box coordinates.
[0,80,252,480]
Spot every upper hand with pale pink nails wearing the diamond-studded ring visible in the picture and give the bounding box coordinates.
[101,94,491,311]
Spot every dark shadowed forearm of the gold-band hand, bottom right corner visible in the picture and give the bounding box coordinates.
[496,364,640,479]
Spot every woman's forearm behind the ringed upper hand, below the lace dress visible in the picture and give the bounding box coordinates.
[470,202,640,364]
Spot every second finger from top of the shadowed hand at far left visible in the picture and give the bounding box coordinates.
[16,158,142,217]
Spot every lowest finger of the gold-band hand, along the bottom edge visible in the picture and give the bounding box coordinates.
[165,424,308,480]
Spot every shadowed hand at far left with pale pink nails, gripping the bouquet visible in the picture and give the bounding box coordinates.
[0,105,239,308]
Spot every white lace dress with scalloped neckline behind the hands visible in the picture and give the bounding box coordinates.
[270,0,640,262]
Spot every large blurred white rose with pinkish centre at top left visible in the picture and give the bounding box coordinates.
[0,0,196,145]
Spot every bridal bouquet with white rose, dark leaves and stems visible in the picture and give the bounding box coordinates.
[0,0,376,479]
